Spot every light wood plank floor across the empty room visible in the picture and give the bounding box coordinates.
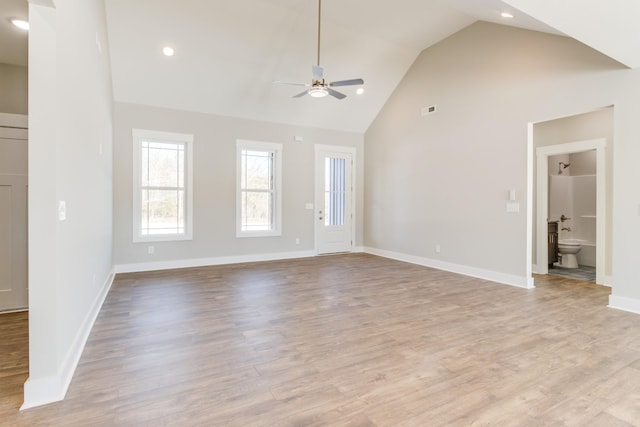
[0,254,640,426]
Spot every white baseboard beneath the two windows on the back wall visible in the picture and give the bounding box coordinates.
[113,251,316,273]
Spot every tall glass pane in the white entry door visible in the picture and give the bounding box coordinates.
[324,157,346,226]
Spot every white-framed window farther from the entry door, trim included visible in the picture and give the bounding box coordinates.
[133,129,193,242]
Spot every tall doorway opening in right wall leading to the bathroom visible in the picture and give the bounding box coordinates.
[529,106,614,285]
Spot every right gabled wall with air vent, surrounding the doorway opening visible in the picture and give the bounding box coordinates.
[365,22,640,311]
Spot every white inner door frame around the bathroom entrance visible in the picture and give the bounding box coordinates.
[536,138,607,285]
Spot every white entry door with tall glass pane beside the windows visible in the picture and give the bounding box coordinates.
[315,145,355,254]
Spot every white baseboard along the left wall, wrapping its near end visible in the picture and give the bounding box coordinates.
[20,270,115,410]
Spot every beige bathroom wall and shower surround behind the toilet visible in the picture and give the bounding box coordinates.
[549,150,597,267]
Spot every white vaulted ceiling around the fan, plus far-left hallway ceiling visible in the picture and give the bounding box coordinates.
[0,0,640,132]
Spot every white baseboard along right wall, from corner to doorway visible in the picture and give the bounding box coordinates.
[364,247,534,289]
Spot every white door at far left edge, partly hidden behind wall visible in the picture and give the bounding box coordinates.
[0,133,28,311]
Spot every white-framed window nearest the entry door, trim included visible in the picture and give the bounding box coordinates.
[236,140,282,237]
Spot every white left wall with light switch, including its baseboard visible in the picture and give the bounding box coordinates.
[23,0,112,408]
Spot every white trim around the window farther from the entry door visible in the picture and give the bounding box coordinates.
[131,129,193,243]
